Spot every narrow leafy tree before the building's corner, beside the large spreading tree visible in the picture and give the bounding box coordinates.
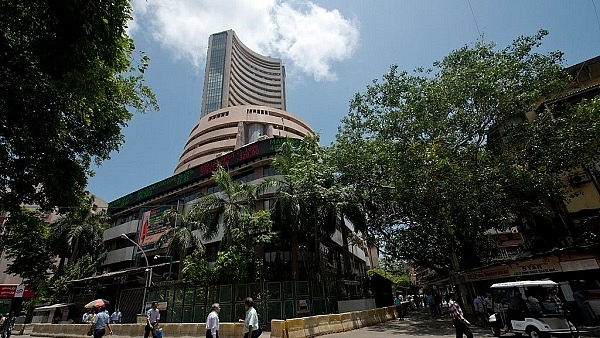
[268,135,346,278]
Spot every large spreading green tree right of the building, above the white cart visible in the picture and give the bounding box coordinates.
[332,31,599,273]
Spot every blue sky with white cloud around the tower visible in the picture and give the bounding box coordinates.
[88,0,600,202]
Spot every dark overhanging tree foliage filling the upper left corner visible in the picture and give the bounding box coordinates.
[0,0,158,211]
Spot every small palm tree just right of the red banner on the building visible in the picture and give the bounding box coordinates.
[156,209,205,278]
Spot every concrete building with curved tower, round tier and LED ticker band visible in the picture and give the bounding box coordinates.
[89,30,377,322]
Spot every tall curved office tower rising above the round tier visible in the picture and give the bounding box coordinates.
[200,30,285,118]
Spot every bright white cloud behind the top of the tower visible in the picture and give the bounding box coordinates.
[129,0,360,81]
